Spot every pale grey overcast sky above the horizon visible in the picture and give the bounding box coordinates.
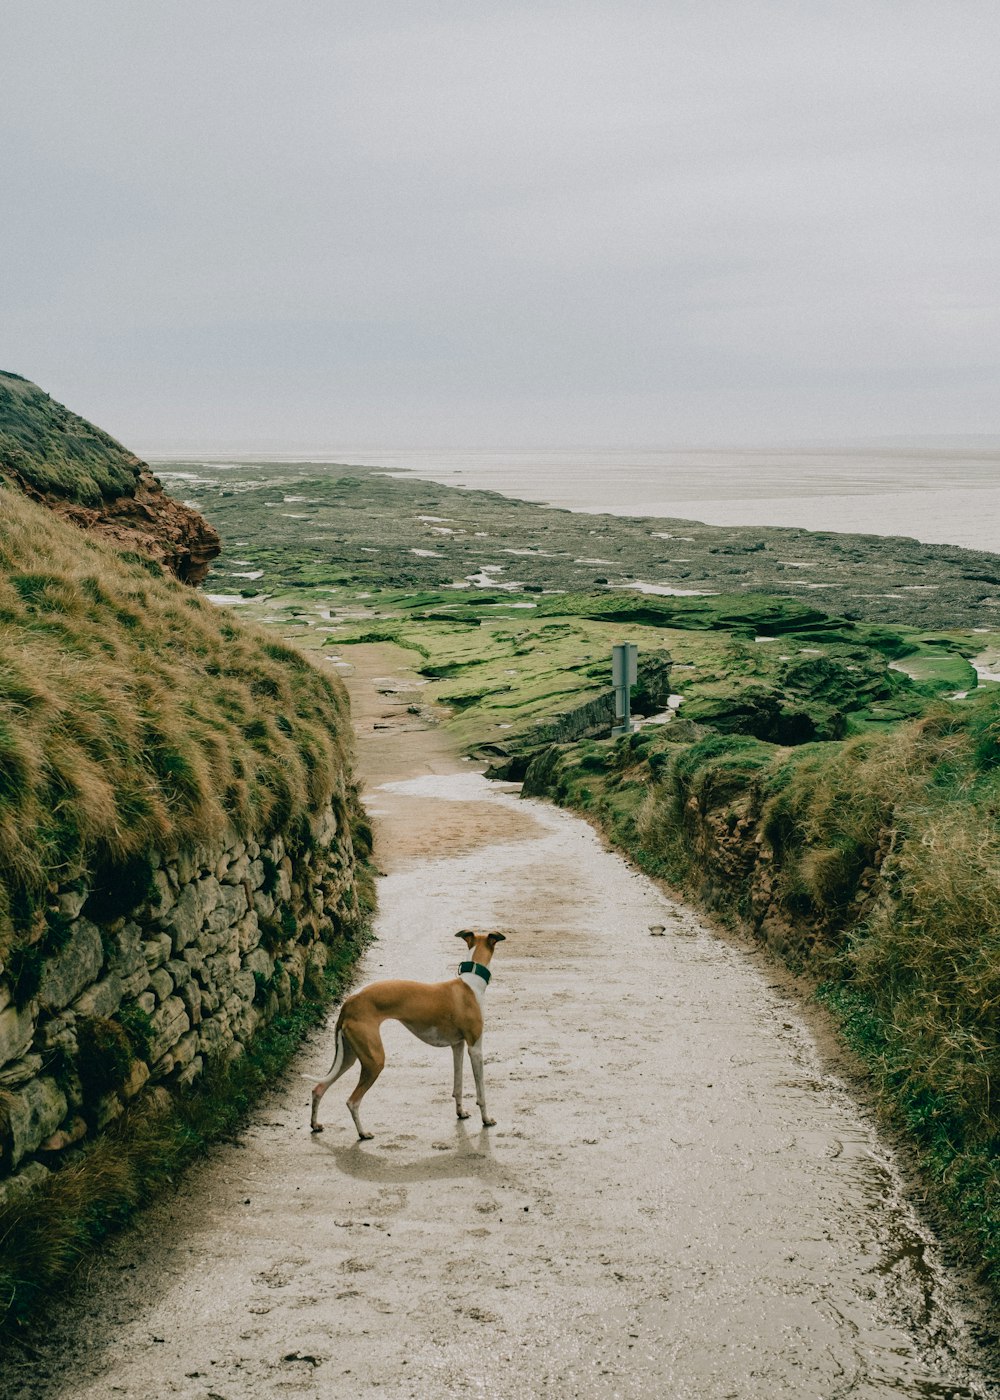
[0,0,1000,451]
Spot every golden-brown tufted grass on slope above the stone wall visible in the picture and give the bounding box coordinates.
[0,486,349,956]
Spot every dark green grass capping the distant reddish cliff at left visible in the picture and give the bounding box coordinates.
[0,372,141,505]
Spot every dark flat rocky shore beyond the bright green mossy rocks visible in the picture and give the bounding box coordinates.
[165,462,1000,629]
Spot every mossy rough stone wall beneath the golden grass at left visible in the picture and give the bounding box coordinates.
[0,795,357,1205]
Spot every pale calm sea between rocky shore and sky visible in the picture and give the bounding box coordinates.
[157,444,1000,553]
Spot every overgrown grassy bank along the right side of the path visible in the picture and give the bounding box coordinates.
[527,687,1000,1287]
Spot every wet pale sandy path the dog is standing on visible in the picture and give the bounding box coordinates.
[8,657,993,1400]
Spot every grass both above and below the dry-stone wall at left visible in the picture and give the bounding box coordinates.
[0,484,371,1319]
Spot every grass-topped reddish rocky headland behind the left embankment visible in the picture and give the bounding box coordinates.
[0,371,221,584]
